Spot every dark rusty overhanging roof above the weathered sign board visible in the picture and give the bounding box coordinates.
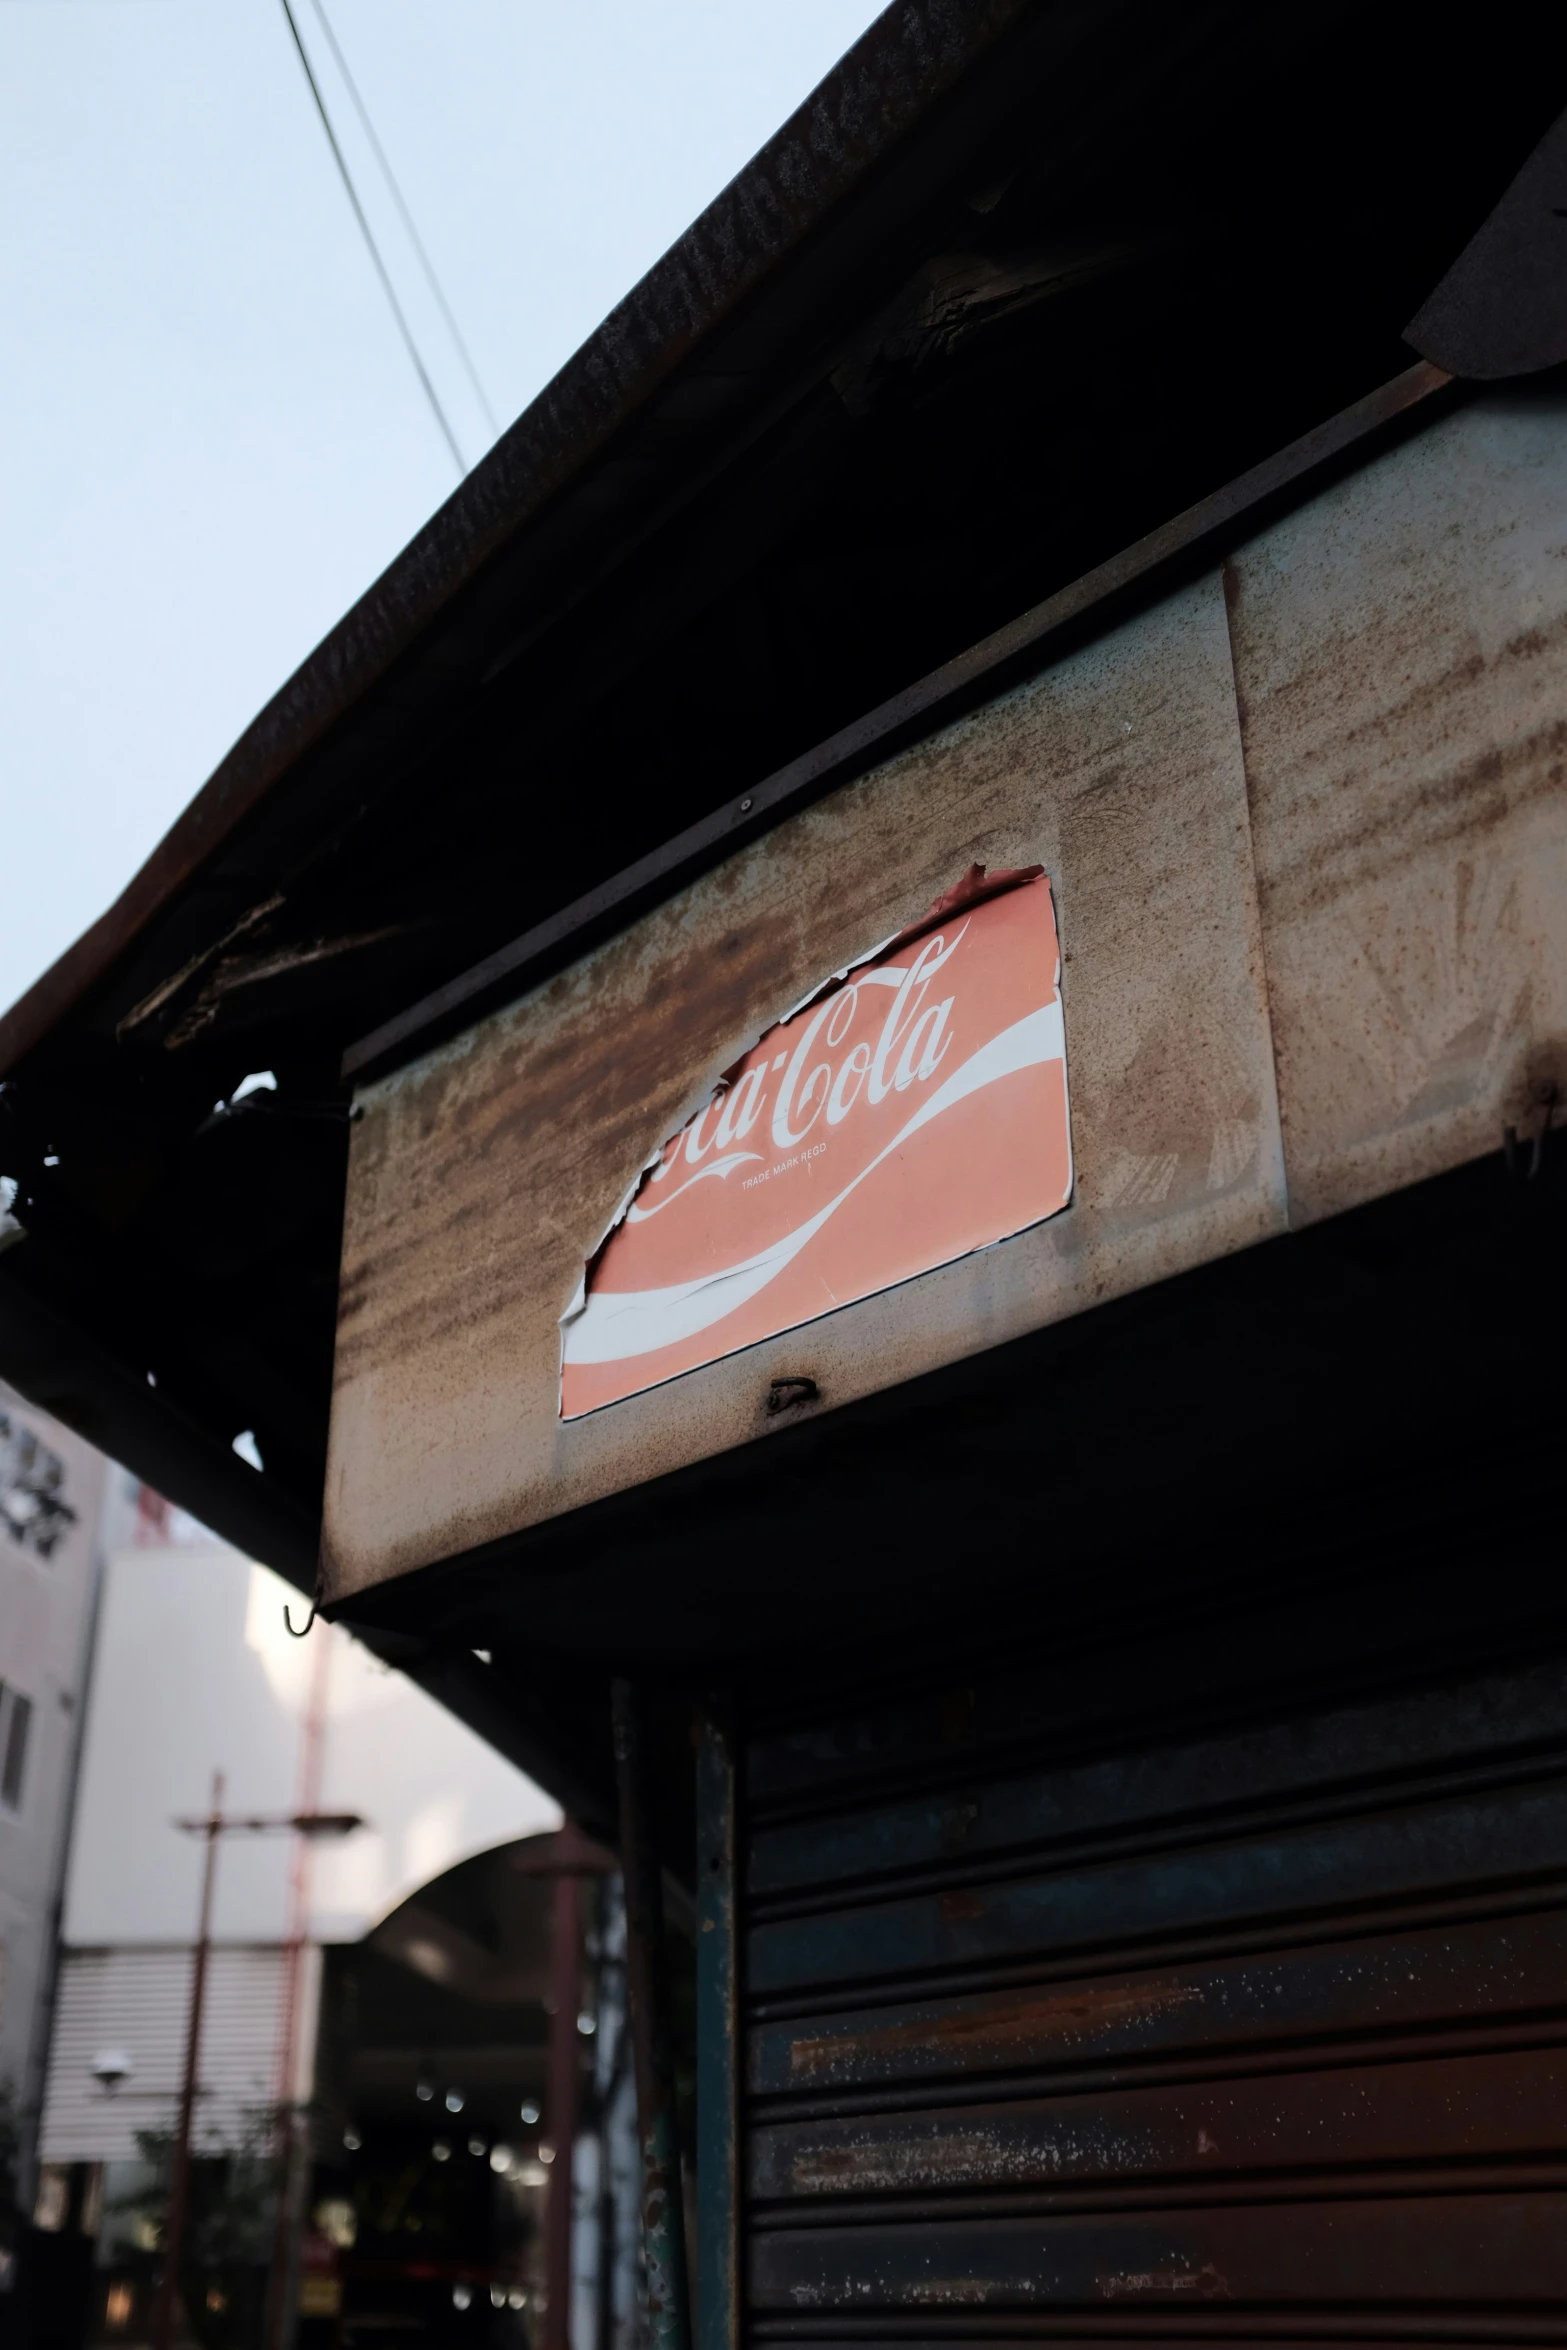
[0,0,1567,1795]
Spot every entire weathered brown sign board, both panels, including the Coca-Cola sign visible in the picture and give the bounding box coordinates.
[324,392,1567,1598]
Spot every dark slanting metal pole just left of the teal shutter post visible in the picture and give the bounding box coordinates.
[613,1680,691,2350]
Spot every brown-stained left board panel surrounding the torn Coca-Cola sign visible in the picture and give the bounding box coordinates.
[324,578,1285,1598]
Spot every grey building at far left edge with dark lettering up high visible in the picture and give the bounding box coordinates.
[0,1382,108,2237]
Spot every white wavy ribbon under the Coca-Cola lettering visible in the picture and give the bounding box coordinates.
[564,996,1067,1363]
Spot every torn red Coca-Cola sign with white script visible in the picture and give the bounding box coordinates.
[561,865,1071,1419]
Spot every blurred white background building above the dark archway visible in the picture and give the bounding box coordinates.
[38,1497,559,2190]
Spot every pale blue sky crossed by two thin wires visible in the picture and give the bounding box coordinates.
[0,0,876,1006]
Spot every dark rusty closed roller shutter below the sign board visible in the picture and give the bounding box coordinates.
[742,1659,1567,2345]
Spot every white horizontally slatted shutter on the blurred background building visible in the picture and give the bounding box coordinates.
[42,1946,284,2162]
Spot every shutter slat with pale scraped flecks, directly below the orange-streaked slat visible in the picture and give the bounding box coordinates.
[747,2047,1567,2202]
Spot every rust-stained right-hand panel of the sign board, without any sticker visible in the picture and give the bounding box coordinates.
[1226,392,1567,1224]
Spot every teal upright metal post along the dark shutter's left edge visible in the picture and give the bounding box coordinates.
[695,1708,740,2350]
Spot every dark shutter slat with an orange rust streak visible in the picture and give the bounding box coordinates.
[747,1908,1567,2099]
